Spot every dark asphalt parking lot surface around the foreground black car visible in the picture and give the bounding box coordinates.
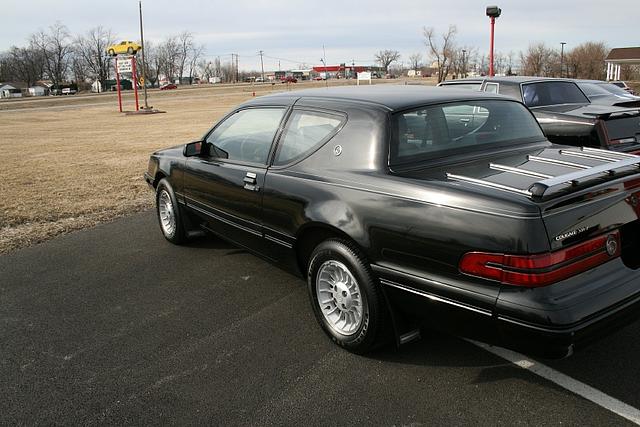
[0,211,640,426]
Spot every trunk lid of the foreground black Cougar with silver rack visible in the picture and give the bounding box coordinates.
[446,146,640,257]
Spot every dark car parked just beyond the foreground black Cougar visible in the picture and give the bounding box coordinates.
[441,77,640,153]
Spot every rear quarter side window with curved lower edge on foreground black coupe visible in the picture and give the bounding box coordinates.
[273,110,344,166]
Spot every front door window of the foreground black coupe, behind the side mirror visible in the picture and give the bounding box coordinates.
[206,107,285,164]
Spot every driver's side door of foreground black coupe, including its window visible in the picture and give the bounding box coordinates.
[184,106,286,251]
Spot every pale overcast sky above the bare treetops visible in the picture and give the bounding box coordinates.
[0,0,640,69]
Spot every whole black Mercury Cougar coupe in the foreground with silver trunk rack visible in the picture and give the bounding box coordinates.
[145,85,640,357]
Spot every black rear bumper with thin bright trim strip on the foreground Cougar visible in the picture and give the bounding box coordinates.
[374,268,640,358]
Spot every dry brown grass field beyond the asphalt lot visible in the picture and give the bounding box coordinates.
[0,81,420,253]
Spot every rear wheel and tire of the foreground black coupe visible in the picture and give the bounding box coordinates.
[307,239,390,354]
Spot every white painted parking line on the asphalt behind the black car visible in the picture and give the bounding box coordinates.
[466,340,640,425]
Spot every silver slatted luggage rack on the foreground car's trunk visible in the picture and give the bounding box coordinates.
[447,147,640,201]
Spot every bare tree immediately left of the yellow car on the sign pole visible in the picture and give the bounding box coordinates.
[74,26,114,87]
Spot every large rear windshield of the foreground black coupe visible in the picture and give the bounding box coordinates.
[389,100,544,166]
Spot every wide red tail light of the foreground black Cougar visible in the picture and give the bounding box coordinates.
[459,231,620,288]
